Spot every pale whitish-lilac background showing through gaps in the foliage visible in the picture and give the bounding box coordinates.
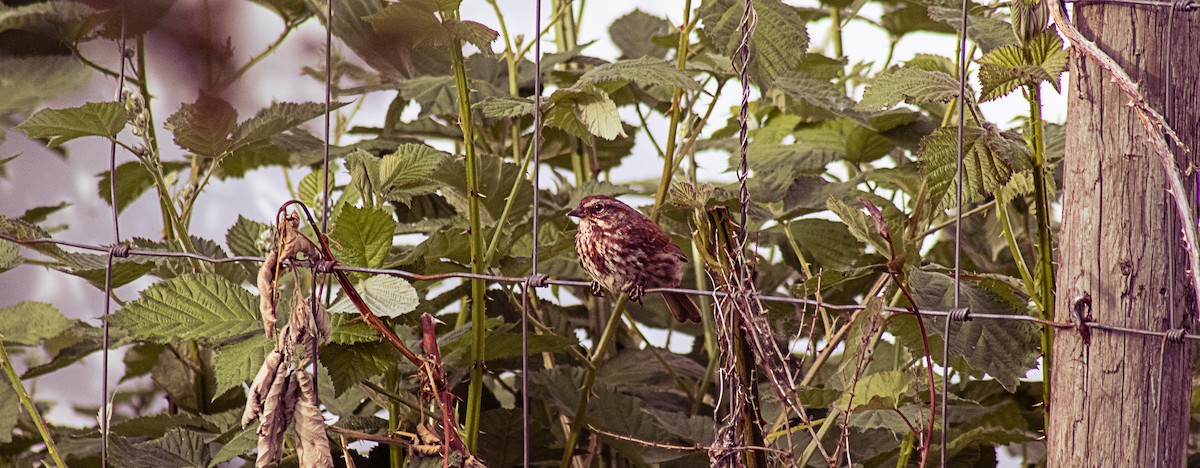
[0,0,1066,460]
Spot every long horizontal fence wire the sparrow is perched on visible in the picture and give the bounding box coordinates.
[0,234,1200,342]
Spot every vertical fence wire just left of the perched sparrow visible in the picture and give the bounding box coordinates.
[523,0,541,467]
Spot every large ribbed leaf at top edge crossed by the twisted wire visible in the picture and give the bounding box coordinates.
[700,0,809,88]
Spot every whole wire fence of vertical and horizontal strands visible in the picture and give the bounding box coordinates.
[0,0,1200,467]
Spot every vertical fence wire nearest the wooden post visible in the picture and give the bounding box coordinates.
[940,0,968,468]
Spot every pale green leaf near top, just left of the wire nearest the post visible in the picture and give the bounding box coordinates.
[858,67,959,110]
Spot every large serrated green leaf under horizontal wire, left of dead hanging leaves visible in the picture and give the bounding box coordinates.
[108,274,262,343]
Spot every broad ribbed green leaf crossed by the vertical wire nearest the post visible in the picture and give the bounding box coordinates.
[918,125,1032,210]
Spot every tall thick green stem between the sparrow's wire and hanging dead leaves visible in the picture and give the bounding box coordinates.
[442,5,487,452]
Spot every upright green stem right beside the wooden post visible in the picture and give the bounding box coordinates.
[1026,84,1055,427]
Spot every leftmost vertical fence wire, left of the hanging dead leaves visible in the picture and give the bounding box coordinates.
[100,11,126,467]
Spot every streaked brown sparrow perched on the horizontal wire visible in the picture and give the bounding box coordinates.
[568,196,700,322]
